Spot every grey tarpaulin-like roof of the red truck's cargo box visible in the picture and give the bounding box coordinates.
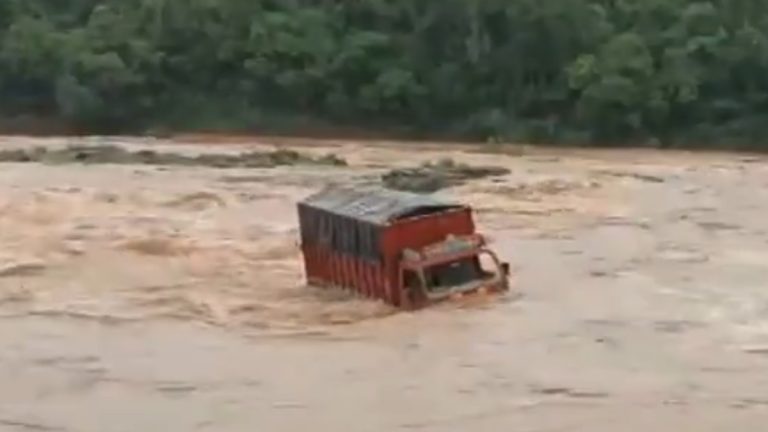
[300,186,465,225]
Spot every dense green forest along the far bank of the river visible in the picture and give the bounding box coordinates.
[0,0,768,149]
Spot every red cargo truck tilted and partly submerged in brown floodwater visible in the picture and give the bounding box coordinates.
[298,186,509,309]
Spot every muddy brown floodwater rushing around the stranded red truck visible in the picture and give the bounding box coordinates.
[0,138,768,432]
